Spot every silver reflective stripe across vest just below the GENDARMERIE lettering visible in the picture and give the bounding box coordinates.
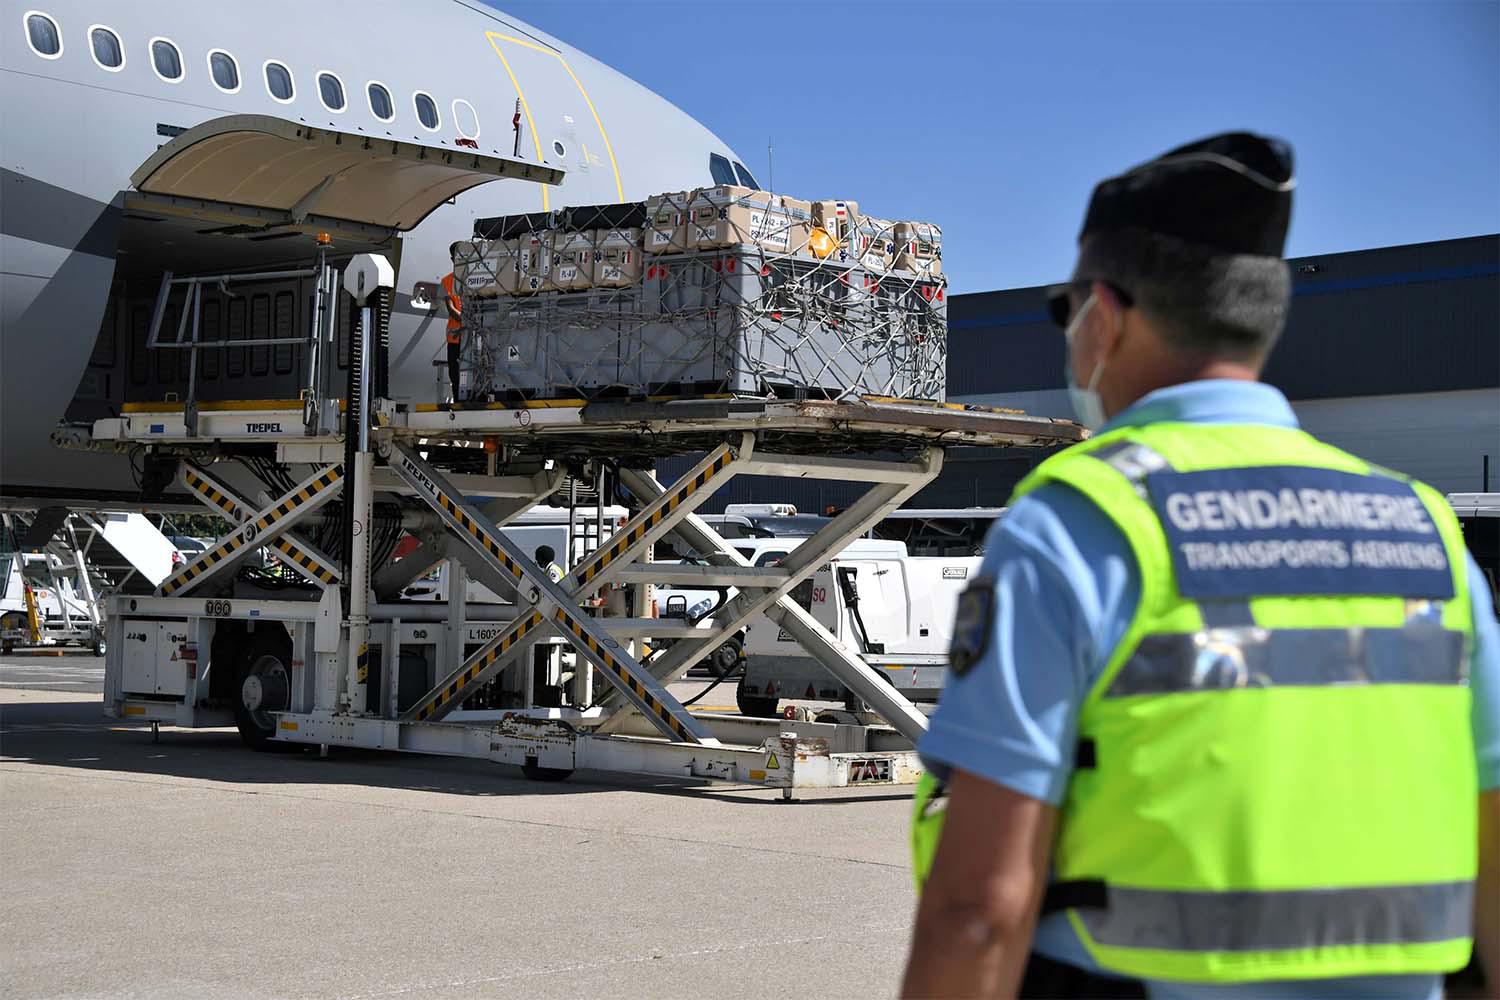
[1104,624,1467,697]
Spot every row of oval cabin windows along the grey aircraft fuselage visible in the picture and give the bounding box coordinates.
[26,10,479,139]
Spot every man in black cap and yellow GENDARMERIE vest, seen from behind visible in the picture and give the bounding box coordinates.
[905,133,1500,999]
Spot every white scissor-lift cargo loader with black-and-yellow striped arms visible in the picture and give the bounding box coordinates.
[75,259,1080,798]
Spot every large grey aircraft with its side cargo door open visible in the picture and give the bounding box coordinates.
[0,0,758,505]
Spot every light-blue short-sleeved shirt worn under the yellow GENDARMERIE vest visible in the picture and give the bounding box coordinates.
[920,379,1500,1000]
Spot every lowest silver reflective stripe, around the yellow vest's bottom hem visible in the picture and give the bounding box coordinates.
[1076,882,1475,952]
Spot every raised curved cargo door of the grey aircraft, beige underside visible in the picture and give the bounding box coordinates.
[126,114,563,241]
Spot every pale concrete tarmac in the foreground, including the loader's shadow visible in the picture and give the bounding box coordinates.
[0,655,914,1000]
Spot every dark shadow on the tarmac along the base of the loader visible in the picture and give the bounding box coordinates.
[0,693,911,807]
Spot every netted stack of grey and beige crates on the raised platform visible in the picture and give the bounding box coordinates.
[453,186,947,403]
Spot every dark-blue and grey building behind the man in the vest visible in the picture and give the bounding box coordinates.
[687,235,1500,511]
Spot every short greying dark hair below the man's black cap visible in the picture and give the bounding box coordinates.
[1074,229,1292,360]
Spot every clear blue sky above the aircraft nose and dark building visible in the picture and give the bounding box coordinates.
[495,0,1500,291]
